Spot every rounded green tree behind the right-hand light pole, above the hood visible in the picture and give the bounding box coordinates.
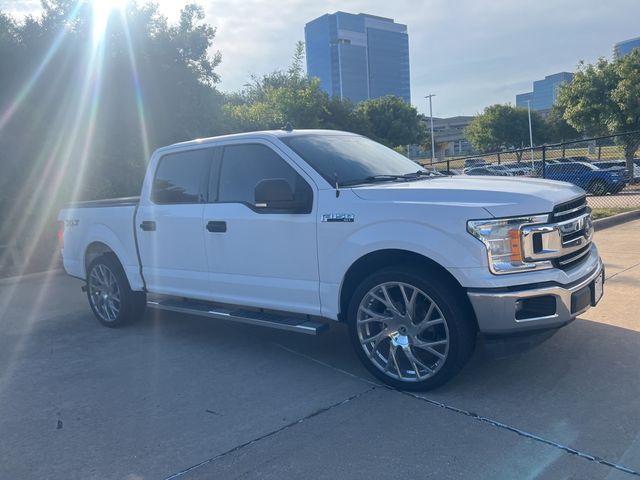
[465,104,547,158]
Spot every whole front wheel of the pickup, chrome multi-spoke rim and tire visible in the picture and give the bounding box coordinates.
[347,265,477,390]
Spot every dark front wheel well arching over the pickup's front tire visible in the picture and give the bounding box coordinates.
[338,250,477,327]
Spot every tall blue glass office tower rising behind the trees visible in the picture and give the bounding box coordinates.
[304,12,411,103]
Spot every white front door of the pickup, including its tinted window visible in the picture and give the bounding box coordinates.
[204,141,320,314]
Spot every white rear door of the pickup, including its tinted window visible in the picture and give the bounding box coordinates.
[135,148,214,298]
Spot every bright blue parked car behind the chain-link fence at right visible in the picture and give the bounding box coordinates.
[545,162,627,195]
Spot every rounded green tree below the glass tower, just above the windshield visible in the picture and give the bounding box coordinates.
[351,96,428,148]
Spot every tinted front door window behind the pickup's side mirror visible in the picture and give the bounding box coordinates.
[218,144,311,205]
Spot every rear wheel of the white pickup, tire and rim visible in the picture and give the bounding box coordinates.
[87,254,147,328]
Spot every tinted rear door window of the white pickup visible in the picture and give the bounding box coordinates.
[151,148,213,204]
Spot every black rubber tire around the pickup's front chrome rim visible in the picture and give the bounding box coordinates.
[347,265,477,391]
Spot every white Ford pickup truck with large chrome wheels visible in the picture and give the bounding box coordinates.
[59,130,604,390]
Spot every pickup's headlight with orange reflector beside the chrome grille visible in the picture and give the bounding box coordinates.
[467,215,552,274]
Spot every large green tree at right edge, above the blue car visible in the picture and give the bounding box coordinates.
[558,50,640,171]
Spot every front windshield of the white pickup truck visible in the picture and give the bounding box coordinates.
[281,134,428,185]
